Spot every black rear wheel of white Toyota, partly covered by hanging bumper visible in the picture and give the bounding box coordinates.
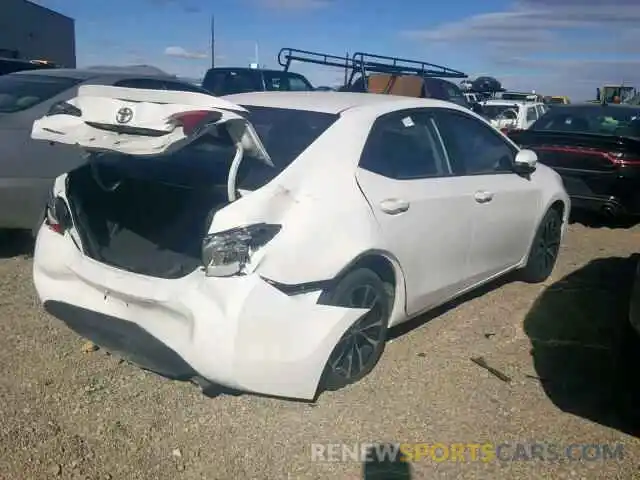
[318,268,393,392]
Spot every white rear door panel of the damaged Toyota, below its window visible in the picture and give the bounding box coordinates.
[358,170,474,314]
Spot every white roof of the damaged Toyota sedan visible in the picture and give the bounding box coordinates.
[223,91,466,114]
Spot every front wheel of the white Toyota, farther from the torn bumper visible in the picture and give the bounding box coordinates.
[521,209,562,283]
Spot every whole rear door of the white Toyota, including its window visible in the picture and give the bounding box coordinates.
[357,109,474,315]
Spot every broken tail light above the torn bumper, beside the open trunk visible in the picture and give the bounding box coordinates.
[202,223,282,277]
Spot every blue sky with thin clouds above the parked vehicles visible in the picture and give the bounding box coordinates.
[36,0,640,99]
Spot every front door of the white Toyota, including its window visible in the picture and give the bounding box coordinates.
[436,109,542,283]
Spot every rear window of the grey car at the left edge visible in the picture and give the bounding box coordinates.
[0,74,80,113]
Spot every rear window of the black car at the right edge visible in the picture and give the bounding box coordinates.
[531,105,640,137]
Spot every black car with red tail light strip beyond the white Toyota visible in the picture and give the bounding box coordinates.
[509,104,640,216]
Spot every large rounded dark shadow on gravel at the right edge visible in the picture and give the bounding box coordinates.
[524,255,640,436]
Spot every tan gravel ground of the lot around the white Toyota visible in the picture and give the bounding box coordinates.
[0,224,640,480]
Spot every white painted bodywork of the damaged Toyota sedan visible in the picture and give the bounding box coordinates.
[34,87,570,399]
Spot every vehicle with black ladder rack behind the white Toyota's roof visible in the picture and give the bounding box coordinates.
[278,48,471,108]
